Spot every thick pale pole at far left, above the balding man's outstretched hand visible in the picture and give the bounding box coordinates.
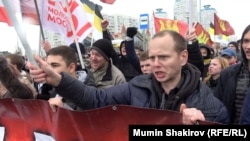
[2,0,38,67]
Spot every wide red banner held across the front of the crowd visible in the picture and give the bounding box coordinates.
[0,99,219,141]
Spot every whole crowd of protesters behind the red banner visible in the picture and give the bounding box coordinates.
[0,21,250,124]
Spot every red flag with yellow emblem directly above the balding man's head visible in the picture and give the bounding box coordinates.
[154,13,188,36]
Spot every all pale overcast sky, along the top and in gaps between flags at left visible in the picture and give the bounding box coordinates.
[0,0,250,52]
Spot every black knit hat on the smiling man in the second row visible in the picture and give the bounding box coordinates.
[92,39,113,60]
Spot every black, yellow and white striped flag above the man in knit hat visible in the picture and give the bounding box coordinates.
[81,0,103,40]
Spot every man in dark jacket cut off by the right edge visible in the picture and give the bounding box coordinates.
[214,25,250,124]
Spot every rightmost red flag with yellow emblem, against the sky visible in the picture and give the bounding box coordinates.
[214,13,235,36]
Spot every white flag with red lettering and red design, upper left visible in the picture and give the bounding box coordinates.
[41,0,93,44]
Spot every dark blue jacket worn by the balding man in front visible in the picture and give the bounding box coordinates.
[56,64,228,123]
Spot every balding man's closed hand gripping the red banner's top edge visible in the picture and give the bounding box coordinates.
[180,104,205,125]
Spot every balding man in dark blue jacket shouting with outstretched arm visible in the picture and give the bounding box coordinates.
[29,30,229,124]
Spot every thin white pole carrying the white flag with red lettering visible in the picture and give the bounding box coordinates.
[65,0,85,69]
